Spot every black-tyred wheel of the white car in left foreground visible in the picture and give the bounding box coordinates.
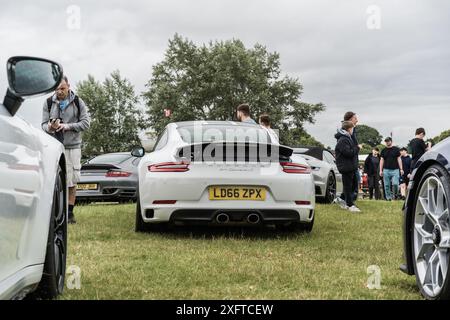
[33,166,67,299]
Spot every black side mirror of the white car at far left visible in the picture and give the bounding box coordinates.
[3,57,63,115]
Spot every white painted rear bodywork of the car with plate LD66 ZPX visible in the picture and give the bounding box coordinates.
[138,123,315,223]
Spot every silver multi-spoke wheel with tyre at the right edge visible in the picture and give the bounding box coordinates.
[410,165,450,300]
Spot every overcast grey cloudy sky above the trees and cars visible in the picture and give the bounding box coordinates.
[0,0,450,146]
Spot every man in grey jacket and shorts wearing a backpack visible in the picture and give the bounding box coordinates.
[42,76,91,223]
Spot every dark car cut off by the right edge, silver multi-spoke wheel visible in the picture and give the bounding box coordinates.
[400,138,450,300]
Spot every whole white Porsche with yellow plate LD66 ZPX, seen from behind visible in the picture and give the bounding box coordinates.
[132,121,315,232]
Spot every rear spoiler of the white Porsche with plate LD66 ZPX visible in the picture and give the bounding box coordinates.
[175,141,294,162]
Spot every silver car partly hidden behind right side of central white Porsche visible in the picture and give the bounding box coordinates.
[293,147,343,203]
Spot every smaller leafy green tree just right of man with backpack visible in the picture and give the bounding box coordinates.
[77,71,147,157]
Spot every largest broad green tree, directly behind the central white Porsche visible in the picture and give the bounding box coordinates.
[143,35,325,144]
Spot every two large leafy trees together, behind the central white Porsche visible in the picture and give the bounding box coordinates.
[76,34,325,156]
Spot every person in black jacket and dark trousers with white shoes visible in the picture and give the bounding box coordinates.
[335,121,361,212]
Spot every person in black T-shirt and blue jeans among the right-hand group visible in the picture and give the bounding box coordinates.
[380,137,404,201]
